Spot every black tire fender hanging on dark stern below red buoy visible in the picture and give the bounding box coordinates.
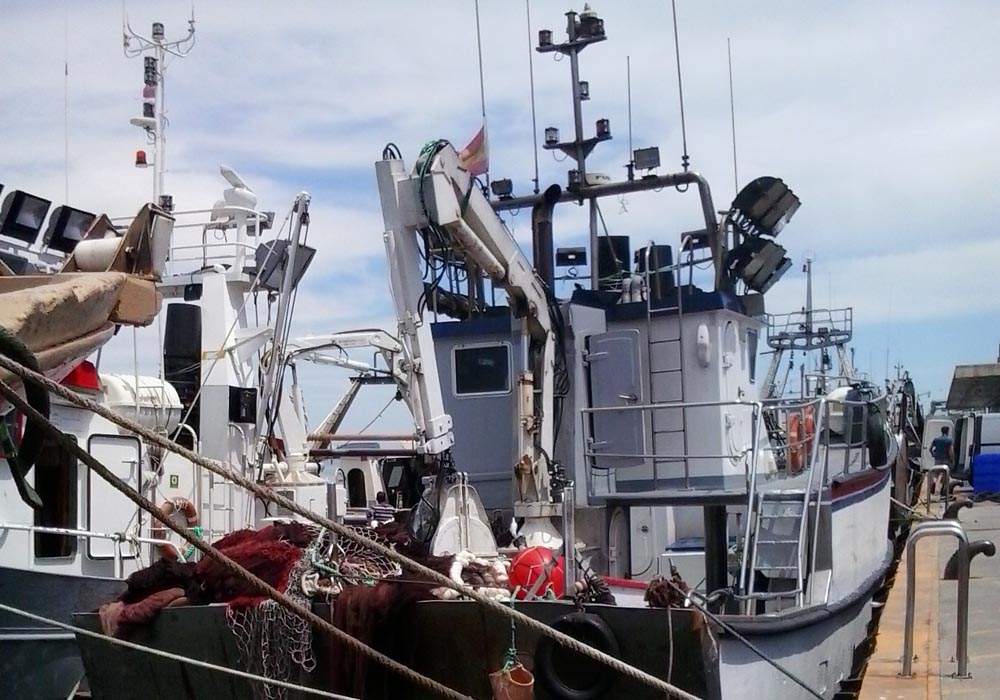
[534,612,621,700]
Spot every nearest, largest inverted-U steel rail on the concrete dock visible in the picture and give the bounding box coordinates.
[899,520,969,678]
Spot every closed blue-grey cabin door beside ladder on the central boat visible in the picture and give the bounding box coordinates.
[586,329,646,469]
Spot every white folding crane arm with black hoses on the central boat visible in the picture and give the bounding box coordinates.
[376,141,561,518]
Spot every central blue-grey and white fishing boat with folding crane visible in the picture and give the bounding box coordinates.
[62,8,915,700]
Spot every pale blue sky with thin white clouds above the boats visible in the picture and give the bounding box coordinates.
[0,0,1000,428]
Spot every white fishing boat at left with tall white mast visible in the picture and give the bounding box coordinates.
[0,20,392,699]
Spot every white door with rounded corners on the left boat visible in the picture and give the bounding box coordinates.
[87,435,142,559]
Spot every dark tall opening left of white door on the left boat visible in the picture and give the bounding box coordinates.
[34,440,80,559]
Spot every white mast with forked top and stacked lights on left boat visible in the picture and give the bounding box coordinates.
[122,2,195,210]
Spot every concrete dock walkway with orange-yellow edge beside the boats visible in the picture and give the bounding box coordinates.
[859,502,1000,700]
